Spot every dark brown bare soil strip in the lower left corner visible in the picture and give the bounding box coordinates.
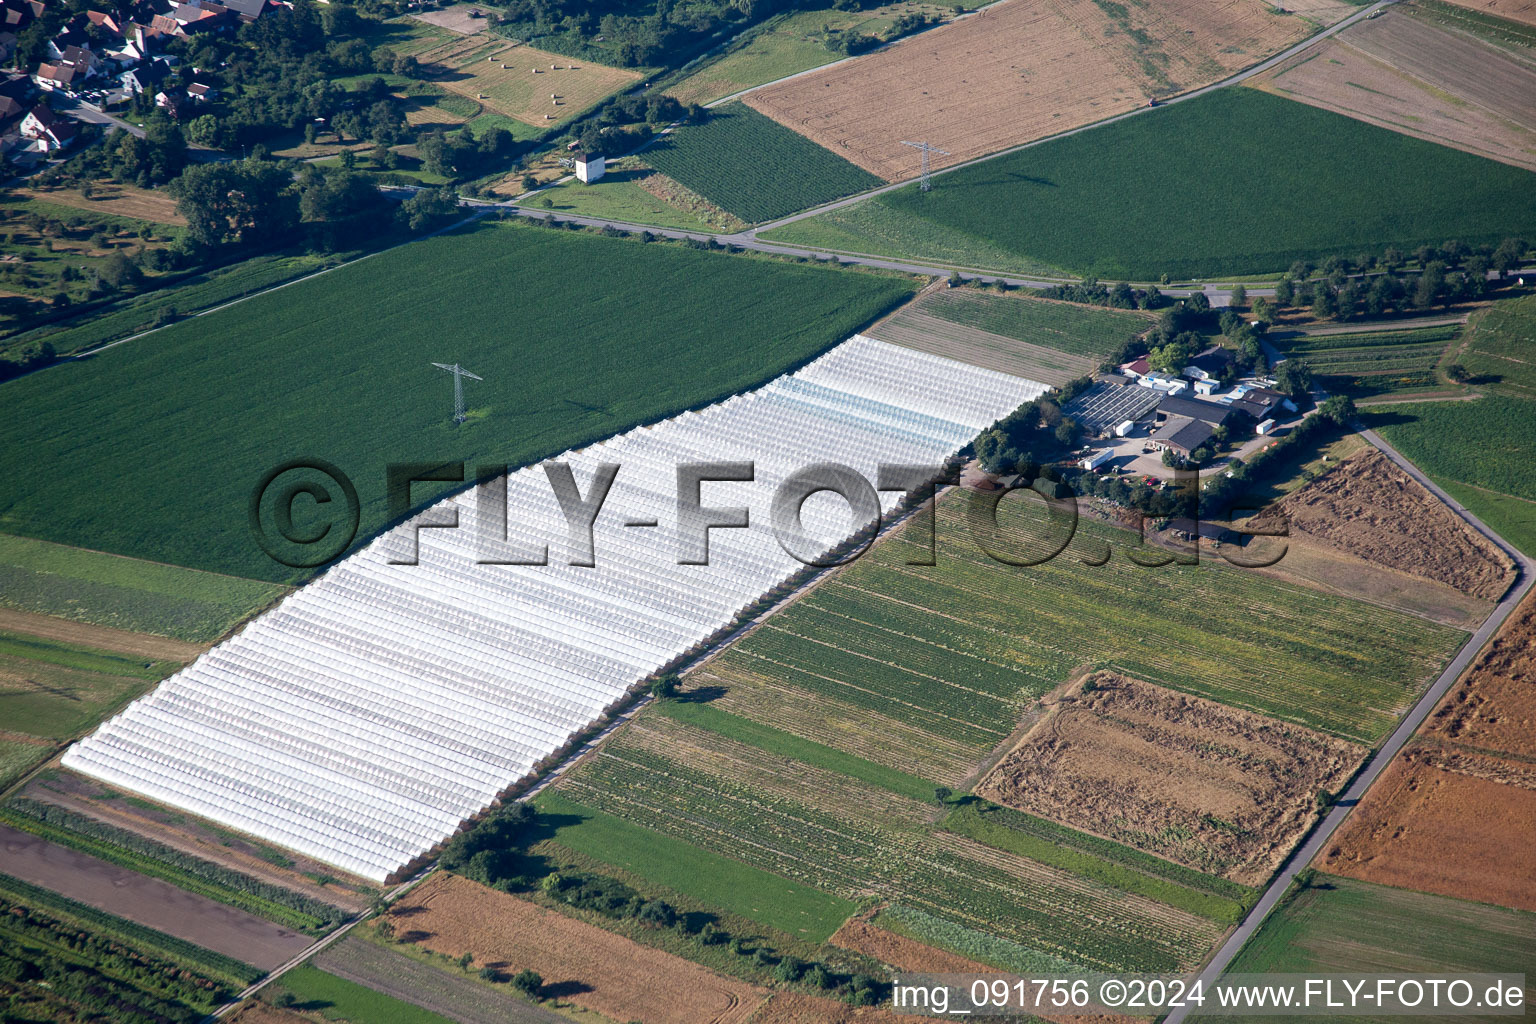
[0,826,312,970]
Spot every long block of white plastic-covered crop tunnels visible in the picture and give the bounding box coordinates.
[63,335,1046,881]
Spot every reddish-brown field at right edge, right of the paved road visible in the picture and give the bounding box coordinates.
[1319,597,1536,910]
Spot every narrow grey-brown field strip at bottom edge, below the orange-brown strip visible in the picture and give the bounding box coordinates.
[313,936,568,1024]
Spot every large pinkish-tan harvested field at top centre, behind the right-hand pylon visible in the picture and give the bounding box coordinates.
[745,0,1352,181]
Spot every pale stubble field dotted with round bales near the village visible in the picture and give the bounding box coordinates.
[416,35,641,127]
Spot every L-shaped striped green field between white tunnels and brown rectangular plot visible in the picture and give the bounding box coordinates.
[700,491,1465,752]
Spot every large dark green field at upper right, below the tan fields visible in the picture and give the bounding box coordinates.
[765,89,1536,281]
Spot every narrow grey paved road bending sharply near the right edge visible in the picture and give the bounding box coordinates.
[1163,424,1536,1024]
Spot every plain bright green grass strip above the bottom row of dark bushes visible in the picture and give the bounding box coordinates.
[535,789,857,941]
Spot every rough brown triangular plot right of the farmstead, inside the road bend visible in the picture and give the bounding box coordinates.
[1263,448,1513,600]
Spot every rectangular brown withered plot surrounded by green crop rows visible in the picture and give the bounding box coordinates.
[977,672,1366,884]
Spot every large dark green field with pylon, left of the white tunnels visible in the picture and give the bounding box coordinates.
[0,223,915,582]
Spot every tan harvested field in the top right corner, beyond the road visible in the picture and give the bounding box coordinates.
[1250,11,1536,170]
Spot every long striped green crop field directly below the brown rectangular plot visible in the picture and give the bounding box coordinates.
[556,714,1221,970]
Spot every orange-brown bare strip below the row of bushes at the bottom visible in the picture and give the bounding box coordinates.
[390,872,763,1024]
